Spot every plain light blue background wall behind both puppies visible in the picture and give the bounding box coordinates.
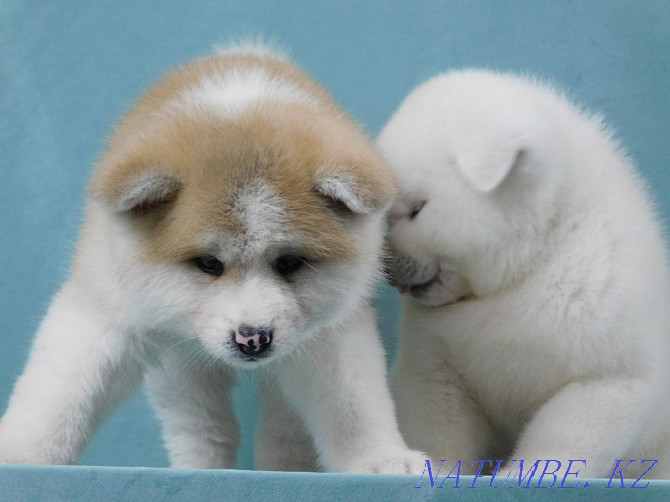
[0,0,670,467]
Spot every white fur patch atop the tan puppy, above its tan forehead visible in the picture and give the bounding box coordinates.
[178,68,318,115]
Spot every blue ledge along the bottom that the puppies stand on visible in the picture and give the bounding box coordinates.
[0,467,670,502]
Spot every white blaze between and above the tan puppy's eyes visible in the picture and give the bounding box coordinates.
[235,182,286,248]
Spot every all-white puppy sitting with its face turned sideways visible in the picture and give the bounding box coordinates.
[378,71,670,476]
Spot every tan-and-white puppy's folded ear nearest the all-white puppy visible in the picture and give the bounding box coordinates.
[315,166,397,214]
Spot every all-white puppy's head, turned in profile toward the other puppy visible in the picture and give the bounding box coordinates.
[378,71,569,305]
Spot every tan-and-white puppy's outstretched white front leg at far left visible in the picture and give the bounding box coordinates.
[0,282,142,464]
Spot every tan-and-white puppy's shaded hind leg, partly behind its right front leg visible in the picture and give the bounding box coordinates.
[254,374,318,471]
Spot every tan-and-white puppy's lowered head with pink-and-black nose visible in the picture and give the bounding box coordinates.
[86,49,395,367]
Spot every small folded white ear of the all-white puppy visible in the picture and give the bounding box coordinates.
[456,149,525,193]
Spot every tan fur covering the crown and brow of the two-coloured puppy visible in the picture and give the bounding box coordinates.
[91,48,396,261]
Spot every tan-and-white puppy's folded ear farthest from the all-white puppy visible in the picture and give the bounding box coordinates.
[90,164,181,214]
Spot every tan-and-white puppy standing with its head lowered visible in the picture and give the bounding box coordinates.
[0,47,425,473]
